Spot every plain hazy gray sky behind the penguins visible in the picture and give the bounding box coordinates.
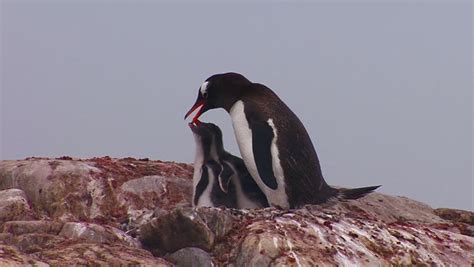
[0,1,474,210]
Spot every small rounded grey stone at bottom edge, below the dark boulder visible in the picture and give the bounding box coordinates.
[166,248,213,267]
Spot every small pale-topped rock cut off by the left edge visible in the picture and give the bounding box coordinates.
[0,189,33,225]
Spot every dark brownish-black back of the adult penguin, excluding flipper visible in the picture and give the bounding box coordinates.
[242,84,337,207]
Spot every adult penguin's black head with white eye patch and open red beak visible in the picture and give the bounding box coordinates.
[184,72,251,122]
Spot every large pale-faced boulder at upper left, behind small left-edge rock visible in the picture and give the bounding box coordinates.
[0,160,103,221]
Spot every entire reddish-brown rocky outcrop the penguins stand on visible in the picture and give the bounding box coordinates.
[0,157,474,266]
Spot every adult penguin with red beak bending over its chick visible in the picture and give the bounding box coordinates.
[185,72,379,209]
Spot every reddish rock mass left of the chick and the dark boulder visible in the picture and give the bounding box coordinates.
[0,157,192,266]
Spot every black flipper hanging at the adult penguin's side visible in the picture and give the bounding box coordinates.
[250,121,278,189]
